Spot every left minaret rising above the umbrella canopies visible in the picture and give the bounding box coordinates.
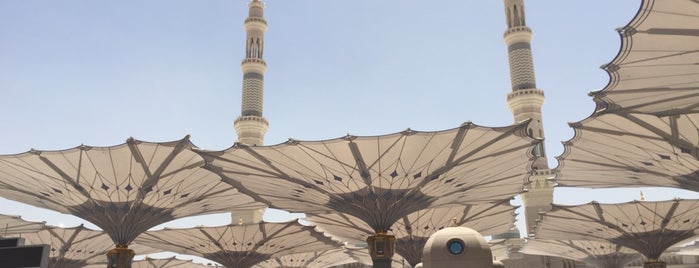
[233,0,269,145]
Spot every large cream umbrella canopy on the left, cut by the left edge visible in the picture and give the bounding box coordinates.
[0,137,263,246]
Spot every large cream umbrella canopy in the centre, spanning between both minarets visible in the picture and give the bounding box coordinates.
[200,122,539,231]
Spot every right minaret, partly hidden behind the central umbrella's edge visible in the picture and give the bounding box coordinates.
[503,0,553,233]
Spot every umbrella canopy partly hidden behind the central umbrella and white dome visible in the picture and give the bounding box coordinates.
[307,200,516,266]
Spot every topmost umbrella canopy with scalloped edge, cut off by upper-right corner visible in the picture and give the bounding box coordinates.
[592,0,699,116]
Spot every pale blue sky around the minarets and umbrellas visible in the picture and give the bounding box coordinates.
[0,0,699,262]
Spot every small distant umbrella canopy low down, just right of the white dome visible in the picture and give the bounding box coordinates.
[522,239,642,268]
